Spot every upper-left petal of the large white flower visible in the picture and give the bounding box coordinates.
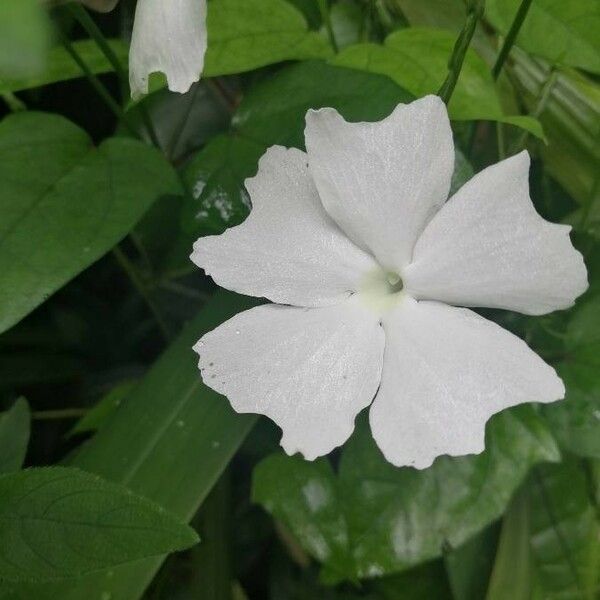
[191,146,377,306]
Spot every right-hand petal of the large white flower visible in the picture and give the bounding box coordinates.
[403,152,587,315]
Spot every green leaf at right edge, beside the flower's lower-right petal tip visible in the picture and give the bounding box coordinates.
[544,295,600,458]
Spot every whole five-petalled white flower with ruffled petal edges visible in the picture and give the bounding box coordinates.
[192,96,587,468]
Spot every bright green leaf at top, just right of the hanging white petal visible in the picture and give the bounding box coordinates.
[204,0,332,77]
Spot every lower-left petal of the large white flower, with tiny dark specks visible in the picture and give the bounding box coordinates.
[194,300,384,460]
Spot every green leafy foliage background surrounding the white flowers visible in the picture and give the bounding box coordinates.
[0,0,600,600]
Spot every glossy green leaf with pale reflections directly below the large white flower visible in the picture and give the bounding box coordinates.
[253,406,558,581]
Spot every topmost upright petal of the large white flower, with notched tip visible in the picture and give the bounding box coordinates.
[305,96,454,271]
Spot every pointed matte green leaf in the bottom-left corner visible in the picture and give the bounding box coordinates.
[0,467,198,581]
